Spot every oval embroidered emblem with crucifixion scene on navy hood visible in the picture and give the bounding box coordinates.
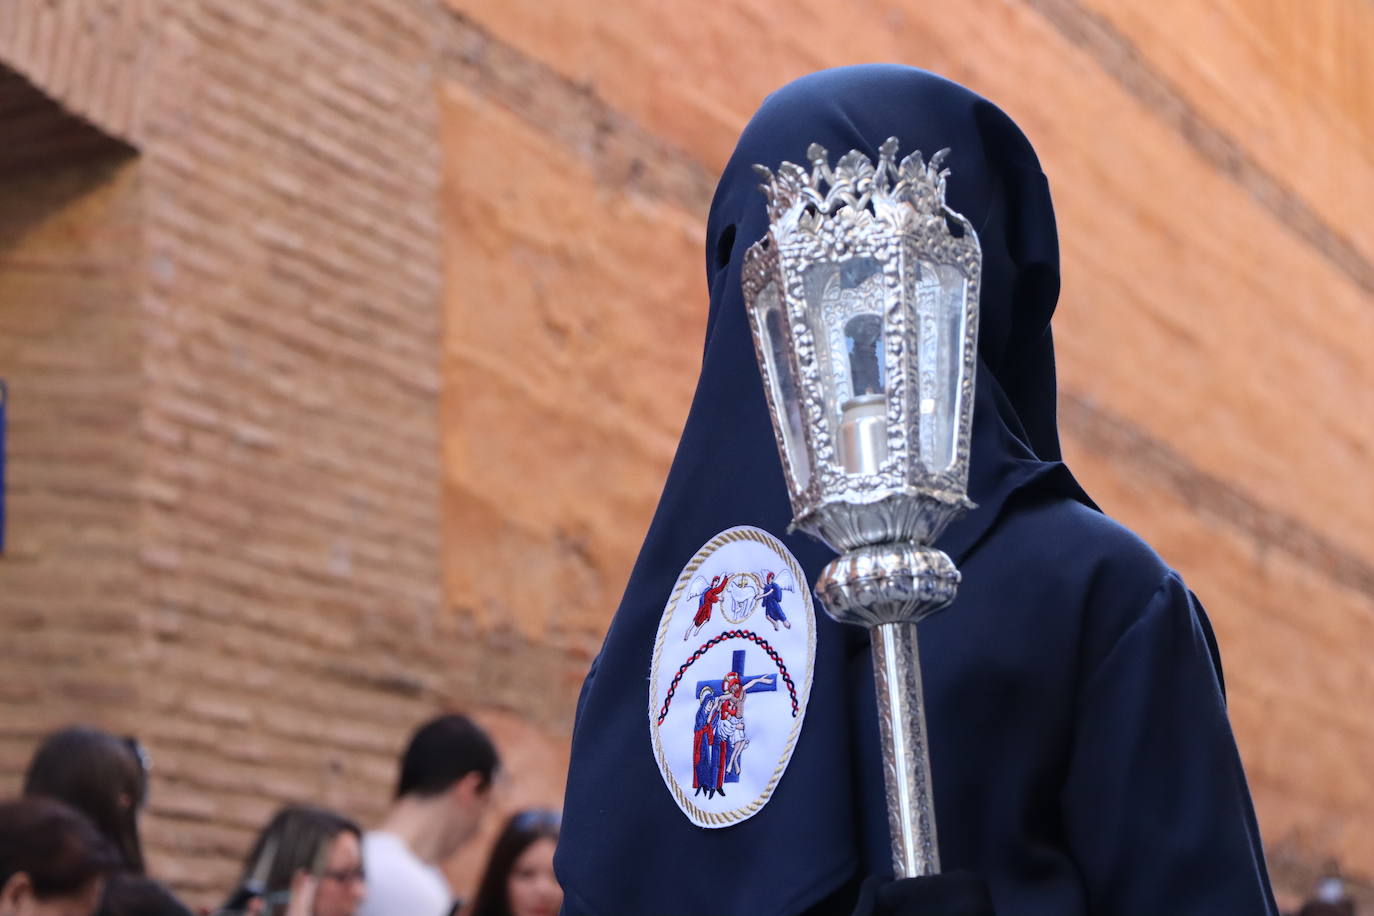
[649,526,816,827]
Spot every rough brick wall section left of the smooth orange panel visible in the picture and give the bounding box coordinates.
[0,1,467,904]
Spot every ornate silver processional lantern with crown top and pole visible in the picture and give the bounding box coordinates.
[743,137,982,878]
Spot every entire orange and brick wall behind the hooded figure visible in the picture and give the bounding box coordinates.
[0,0,1374,902]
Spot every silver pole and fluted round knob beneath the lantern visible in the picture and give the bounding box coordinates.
[816,542,959,878]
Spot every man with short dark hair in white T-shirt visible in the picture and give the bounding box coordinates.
[359,714,500,916]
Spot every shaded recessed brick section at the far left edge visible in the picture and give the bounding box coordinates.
[0,89,142,773]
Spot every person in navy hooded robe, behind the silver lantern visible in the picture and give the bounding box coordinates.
[556,65,1275,916]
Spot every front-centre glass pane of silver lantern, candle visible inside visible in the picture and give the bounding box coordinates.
[802,258,888,474]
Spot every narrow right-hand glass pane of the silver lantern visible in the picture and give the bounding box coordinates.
[915,261,967,471]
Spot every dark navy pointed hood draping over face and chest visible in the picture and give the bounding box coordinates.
[558,65,1110,916]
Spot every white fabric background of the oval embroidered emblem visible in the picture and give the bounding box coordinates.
[649,526,816,827]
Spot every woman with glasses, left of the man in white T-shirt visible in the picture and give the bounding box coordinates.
[220,805,365,916]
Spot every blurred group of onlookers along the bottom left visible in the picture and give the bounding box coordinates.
[0,715,563,916]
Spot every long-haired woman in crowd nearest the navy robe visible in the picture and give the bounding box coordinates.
[466,809,563,916]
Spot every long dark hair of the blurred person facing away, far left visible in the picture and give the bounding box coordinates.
[23,725,148,875]
